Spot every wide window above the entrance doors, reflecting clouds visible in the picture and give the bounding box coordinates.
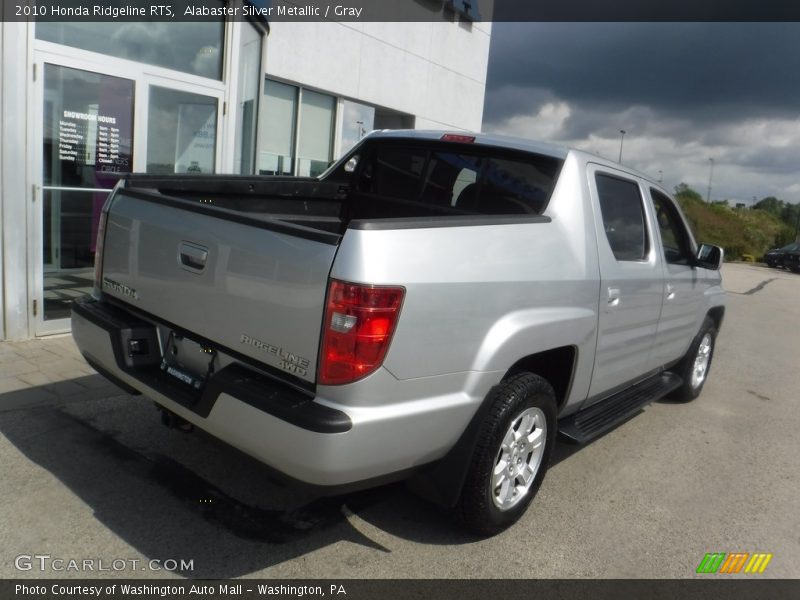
[36,19,225,81]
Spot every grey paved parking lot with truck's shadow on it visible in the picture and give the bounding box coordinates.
[0,264,800,579]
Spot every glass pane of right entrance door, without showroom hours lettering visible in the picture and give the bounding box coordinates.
[147,86,217,175]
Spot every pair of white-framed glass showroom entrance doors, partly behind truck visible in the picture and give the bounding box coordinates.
[29,61,224,336]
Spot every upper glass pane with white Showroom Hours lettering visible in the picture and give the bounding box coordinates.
[43,65,134,189]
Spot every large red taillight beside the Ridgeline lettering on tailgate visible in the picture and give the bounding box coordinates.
[319,280,405,385]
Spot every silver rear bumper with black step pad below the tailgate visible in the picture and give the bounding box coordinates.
[72,297,475,491]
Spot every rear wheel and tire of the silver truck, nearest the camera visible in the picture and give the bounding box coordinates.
[457,373,556,535]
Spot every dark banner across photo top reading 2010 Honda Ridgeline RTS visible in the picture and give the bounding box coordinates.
[2,0,800,22]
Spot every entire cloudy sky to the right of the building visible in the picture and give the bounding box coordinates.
[483,23,800,205]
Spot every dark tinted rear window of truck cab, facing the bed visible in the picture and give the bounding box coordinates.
[356,144,562,215]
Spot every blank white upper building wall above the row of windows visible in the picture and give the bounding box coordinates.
[266,20,491,131]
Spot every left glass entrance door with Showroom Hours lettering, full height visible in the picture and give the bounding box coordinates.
[34,63,134,335]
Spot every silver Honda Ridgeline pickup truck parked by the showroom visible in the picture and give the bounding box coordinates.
[72,131,725,535]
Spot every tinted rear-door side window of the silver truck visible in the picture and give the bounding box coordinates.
[595,173,647,260]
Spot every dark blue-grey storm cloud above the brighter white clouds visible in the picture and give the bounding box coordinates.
[484,23,800,125]
